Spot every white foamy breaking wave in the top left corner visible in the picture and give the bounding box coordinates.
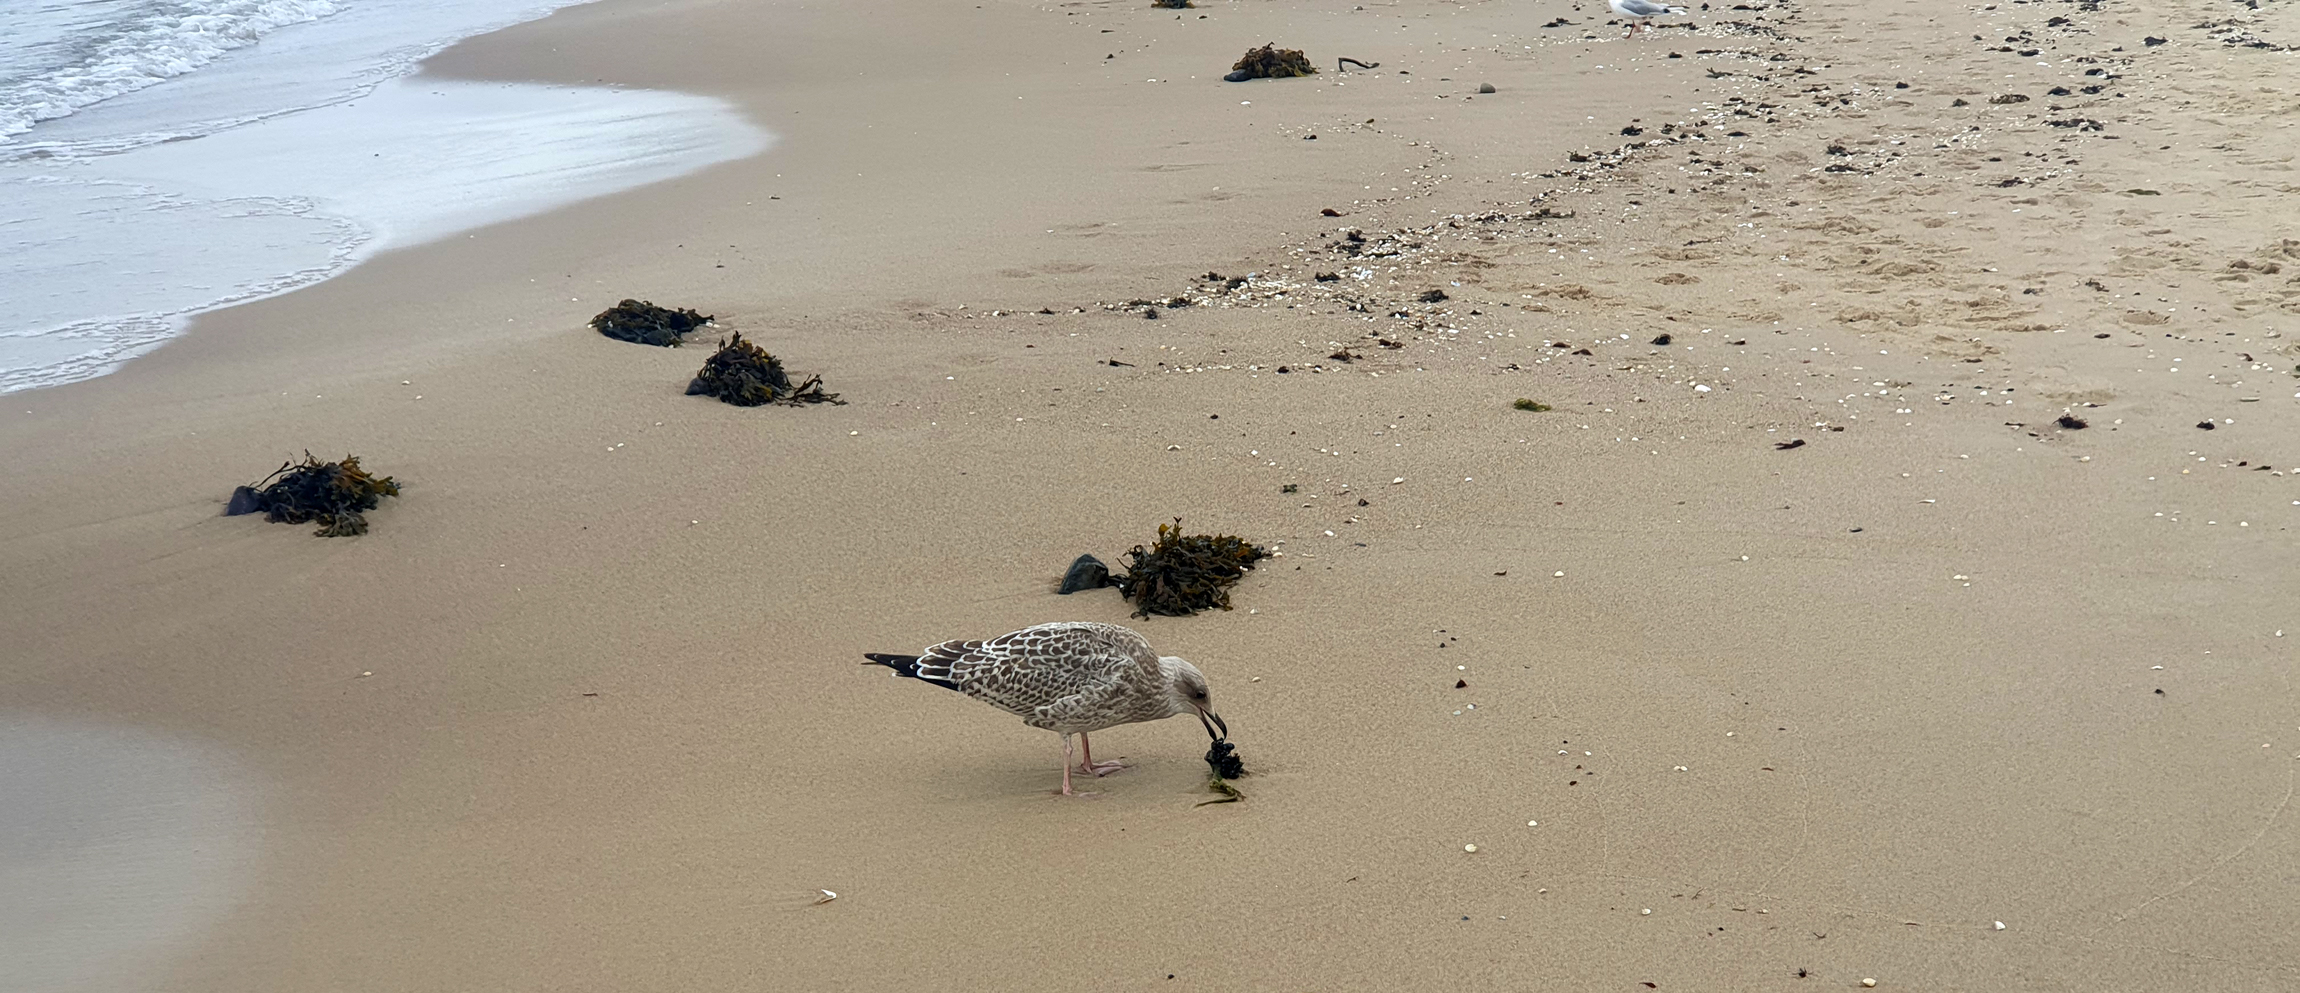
[0,0,343,143]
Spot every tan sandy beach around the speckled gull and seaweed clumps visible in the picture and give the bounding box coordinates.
[0,0,2300,993]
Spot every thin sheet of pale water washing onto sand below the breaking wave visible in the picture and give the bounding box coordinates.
[0,0,771,393]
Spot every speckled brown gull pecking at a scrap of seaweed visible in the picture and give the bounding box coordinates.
[863,621,1231,795]
